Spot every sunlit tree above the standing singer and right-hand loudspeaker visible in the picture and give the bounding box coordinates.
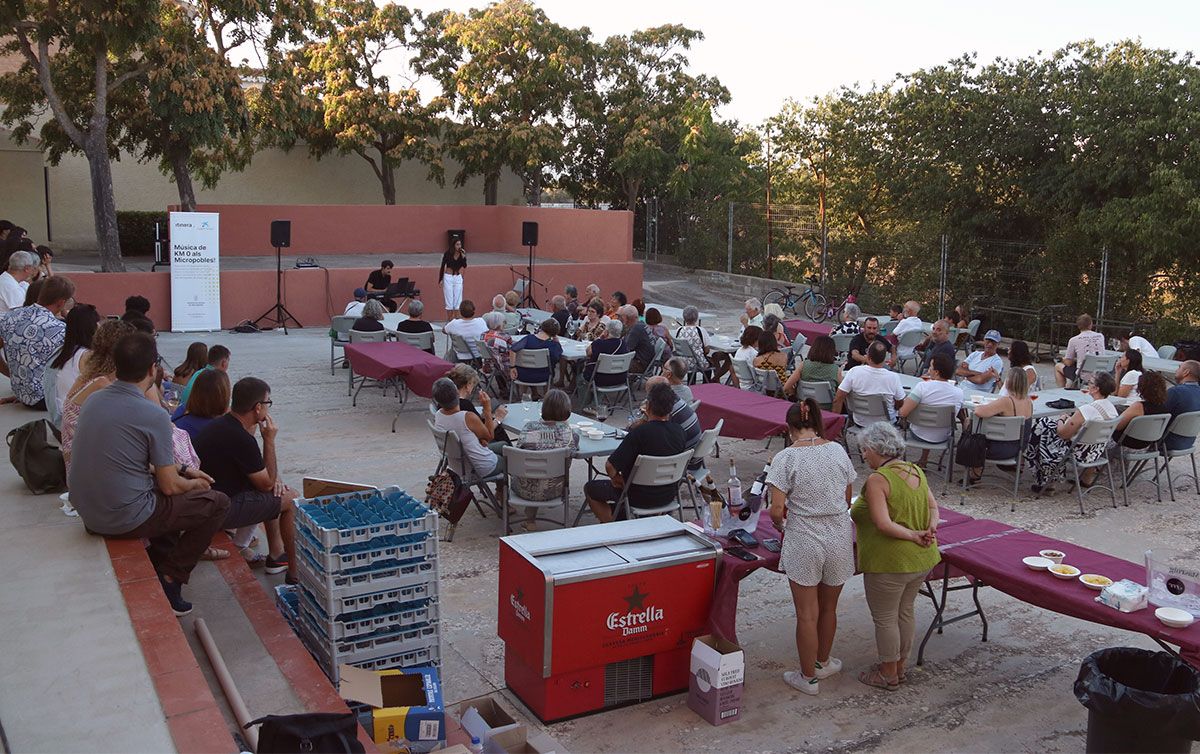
[418,0,592,204]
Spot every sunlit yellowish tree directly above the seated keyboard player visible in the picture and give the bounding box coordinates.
[256,0,444,204]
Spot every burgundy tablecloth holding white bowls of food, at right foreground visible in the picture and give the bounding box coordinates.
[941,519,1200,666]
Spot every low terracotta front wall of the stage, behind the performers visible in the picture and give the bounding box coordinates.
[63,259,642,330]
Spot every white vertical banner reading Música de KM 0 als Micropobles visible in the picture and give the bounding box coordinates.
[169,213,221,333]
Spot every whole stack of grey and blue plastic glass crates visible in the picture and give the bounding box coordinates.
[296,486,442,683]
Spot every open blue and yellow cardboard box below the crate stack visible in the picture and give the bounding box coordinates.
[338,665,445,752]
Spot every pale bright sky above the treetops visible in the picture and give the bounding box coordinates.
[403,0,1200,125]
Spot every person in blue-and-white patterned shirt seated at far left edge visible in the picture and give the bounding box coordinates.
[0,276,74,411]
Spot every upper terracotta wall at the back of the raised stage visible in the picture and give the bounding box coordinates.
[197,204,634,264]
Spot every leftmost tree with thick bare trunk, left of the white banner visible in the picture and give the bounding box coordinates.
[0,0,158,271]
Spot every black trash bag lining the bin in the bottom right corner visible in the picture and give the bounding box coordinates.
[1075,647,1200,752]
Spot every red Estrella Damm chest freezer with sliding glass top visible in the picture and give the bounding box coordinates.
[498,516,721,722]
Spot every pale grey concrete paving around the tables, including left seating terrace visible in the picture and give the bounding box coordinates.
[0,261,1200,754]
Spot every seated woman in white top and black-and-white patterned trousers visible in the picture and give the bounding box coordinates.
[1025,372,1117,493]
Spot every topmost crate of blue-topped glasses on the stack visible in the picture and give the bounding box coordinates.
[296,486,438,552]
